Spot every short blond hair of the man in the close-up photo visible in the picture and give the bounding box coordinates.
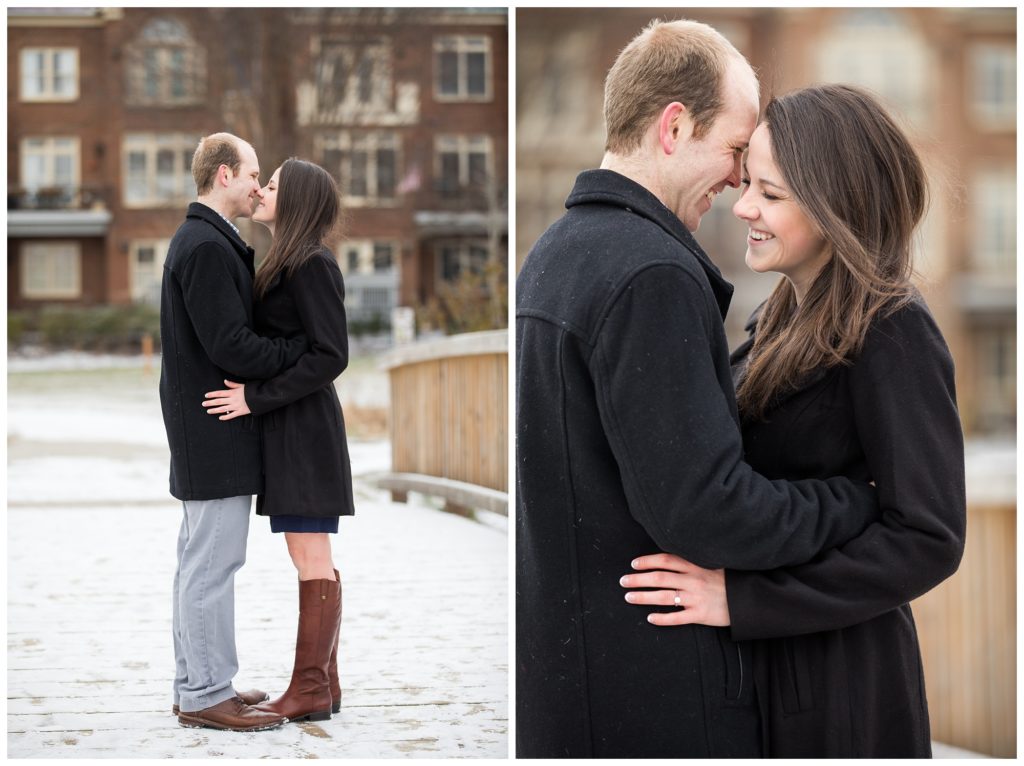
[604,18,745,155]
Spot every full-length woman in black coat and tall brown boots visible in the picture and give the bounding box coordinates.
[203,159,354,721]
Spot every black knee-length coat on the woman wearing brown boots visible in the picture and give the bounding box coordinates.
[246,250,355,518]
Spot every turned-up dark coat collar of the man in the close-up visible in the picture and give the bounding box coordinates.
[565,170,733,321]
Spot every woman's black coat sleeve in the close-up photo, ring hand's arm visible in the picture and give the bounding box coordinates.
[726,304,967,639]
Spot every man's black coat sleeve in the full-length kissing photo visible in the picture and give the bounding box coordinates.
[176,242,307,380]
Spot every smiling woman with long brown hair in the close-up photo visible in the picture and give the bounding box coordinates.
[622,86,966,758]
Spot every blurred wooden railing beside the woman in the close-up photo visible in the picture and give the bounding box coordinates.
[912,502,1017,758]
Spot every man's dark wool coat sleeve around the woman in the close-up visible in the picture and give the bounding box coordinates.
[591,265,878,569]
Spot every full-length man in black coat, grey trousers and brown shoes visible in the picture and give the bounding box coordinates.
[160,133,299,731]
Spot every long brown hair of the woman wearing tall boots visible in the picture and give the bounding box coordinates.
[254,158,341,298]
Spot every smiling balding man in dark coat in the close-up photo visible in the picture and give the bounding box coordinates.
[516,22,878,758]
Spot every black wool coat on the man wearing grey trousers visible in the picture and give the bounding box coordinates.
[160,202,307,500]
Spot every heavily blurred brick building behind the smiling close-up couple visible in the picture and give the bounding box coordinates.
[516,8,1017,434]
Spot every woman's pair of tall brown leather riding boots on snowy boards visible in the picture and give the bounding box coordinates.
[257,580,341,721]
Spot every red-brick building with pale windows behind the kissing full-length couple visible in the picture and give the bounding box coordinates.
[7,7,508,335]
